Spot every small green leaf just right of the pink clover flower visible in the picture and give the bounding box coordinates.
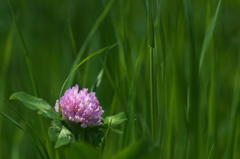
[103,112,127,125]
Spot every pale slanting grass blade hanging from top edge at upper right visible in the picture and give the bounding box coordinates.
[199,0,222,71]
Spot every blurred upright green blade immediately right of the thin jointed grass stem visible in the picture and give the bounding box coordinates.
[155,0,166,150]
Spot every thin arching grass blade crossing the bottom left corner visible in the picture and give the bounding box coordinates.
[0,111,47,159]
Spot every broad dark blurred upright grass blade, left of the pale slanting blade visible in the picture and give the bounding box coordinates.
[183,0,201,158]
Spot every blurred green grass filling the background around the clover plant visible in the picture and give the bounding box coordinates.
[0,0,240,159]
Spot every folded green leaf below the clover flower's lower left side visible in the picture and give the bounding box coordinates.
[48,120,73,148]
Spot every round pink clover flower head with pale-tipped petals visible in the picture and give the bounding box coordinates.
[55,85,104,128]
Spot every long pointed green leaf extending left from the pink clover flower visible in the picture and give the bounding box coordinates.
[10,92,58,119]
